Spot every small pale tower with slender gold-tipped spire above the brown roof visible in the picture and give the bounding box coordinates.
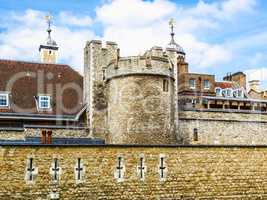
[39,15,58,63]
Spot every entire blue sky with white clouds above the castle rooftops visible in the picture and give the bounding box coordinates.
[0,0,267,88]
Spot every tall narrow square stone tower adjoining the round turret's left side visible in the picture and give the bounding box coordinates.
[84,40,119,139]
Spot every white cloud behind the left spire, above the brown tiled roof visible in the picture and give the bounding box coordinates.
[0,10,96,72]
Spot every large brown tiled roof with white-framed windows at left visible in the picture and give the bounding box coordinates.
[0,60,83,115]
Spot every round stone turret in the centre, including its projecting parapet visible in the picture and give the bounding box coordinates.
[106,47,176,144]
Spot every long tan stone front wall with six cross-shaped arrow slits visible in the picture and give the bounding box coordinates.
[0,146,267,200]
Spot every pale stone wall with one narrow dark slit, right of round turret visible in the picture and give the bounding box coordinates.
[178,111,267,145]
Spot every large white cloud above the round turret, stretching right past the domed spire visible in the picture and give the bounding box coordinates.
[97,0,255,68]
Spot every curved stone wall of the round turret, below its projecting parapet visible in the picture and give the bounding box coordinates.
[107,74,176,144]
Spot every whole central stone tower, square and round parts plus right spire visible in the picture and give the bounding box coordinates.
[84,18,185,144]
